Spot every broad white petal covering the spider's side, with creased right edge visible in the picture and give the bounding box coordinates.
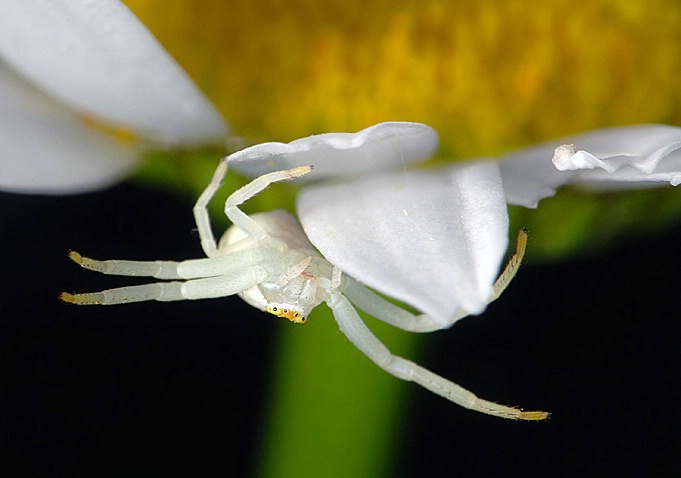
[297,162,508,327]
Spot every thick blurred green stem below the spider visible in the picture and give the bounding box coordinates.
[259,308,418,478]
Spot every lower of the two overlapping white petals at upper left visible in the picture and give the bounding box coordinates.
[0,62,137,193]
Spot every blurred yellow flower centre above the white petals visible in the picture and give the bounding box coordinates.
[125,0,681,158]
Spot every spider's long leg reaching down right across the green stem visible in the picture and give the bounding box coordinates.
[327,293,548,420]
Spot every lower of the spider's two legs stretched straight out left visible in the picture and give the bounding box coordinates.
[60,265,268,305]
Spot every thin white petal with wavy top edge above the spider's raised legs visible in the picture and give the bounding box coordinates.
[229,122,438,180]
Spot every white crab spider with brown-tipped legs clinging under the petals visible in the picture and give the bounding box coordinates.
[60,159,548,420]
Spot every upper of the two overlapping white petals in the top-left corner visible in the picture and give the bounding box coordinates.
[0,0,227,143]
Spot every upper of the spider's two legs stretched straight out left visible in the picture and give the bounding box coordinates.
[69,249,264,279]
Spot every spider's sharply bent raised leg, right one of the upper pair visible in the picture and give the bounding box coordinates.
[224,166,312,240]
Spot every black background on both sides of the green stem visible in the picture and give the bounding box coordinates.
[0,184,681,477]
